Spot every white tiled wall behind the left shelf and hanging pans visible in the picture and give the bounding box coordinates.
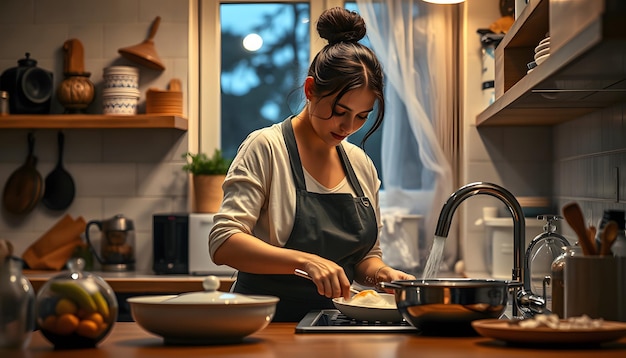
[0,0,189,271]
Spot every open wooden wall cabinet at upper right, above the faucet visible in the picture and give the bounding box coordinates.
[476,0,626,126]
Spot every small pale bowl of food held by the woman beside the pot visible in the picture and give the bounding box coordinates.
[333,293,402,322]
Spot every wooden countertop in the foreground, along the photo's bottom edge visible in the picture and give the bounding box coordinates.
[8,322,626,358]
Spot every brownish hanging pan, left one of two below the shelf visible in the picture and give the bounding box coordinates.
[3,133,42,215]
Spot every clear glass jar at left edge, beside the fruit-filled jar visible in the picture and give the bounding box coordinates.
[0,256,35,349]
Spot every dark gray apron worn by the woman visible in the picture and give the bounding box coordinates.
[234,118,378,322]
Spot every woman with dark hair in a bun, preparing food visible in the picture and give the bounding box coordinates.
[209,7,414,322]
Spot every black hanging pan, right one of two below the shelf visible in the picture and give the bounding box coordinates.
[41,132,76,210]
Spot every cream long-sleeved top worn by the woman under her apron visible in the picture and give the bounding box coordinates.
[209,123,382,259]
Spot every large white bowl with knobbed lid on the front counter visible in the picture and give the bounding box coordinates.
[127,276,278,345]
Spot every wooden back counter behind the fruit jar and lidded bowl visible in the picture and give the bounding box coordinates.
[24,270,234,293]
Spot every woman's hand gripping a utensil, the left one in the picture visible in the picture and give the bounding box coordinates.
[303,255,350,299]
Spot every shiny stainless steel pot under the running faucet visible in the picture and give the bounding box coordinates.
[379,278,522,336]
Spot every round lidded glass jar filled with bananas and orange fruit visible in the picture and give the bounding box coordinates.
[36,258,118,349]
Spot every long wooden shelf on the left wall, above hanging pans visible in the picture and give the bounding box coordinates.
[0,114,188,131]
